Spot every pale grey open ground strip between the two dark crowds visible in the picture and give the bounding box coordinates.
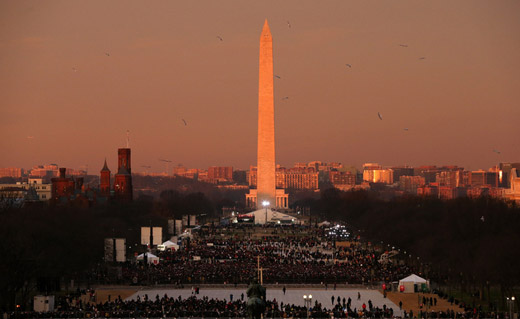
[126,288,402,316]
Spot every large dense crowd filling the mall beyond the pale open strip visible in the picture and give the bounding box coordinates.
[123,237,413,284]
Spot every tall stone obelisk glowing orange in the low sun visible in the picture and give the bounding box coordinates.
[256,19,276,207]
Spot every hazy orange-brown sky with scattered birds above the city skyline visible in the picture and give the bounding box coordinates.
[0,0,520,173]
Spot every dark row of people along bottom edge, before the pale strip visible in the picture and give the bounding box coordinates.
[7,295,504,319]
